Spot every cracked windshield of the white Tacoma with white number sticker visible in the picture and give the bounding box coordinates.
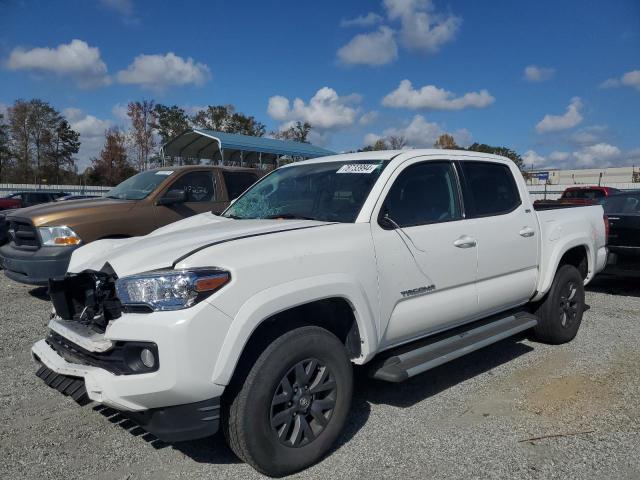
[223,160,388,222]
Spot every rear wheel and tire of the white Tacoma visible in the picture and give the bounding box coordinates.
[533,265,585,345]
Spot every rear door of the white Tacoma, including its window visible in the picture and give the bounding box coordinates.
[458,160,539,316]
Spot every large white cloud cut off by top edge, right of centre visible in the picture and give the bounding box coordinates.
[384,0,462,53]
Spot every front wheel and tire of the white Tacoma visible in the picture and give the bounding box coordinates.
[222,326,353,477]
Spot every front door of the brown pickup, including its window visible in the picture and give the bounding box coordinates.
[154,170,224,227]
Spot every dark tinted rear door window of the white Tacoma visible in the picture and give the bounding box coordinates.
[461,161,522,217]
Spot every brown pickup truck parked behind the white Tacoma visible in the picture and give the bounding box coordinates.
[0,165,260,285]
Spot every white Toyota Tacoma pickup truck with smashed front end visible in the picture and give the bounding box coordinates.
[32,150,607,476]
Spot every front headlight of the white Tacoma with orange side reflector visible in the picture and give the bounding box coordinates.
[116,268,231,310]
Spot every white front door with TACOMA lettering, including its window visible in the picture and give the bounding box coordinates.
[371,160,478,347]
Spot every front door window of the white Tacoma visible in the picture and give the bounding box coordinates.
[381,162,462,227]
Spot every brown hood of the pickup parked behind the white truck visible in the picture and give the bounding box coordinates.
[9,198,136,227]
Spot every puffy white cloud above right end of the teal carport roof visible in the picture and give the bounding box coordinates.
[267,87,361,130]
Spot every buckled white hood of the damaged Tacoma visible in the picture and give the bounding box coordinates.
[69,213,331,277]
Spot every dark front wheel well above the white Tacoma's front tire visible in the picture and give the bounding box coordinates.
[231,298,361,385]
